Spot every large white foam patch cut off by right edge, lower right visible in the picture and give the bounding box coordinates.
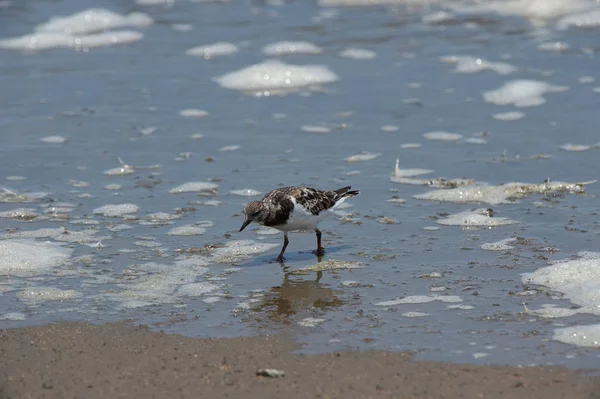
[522,253,600,315]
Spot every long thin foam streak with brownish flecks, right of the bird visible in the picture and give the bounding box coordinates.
[414,181,585,205]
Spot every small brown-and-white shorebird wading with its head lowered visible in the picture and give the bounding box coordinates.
[240,186,360,262]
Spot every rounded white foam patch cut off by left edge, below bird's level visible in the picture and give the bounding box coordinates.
[0,240,73,277]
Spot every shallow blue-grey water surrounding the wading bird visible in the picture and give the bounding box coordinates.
[0,0,600,367]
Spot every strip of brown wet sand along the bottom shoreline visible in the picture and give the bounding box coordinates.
[0,323,600,399]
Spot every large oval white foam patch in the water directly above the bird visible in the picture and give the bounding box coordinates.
[214,60,339,92]
